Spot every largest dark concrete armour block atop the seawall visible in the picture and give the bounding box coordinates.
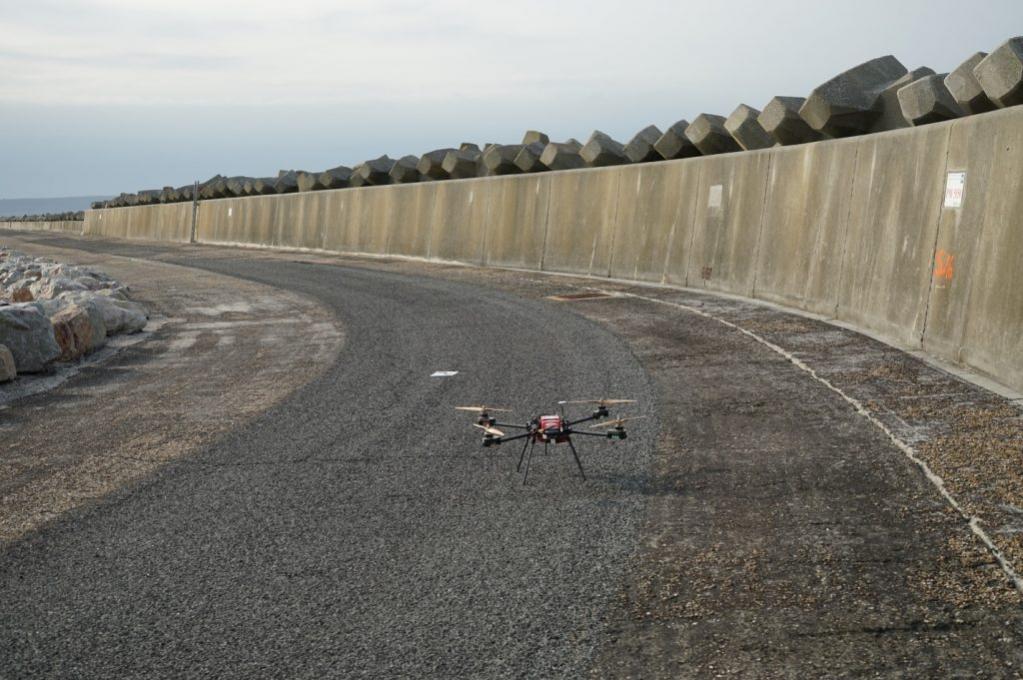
[799,54,907,137]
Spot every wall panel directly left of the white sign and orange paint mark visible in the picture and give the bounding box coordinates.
[838,126,948,346]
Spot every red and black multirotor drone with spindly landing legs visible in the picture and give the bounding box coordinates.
[455,399,647,484]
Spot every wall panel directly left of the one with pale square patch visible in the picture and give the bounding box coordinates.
[611,161,700,283]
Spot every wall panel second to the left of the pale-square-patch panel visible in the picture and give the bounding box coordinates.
[543,167,621,276]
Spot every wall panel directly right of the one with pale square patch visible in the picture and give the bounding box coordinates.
[753,140,857,316]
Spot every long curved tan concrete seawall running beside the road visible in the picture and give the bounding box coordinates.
[68,107,1023,391]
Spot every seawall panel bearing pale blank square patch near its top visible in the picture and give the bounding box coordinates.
[687,151,773,296]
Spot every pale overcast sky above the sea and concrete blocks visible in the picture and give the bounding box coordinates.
[0,0,1023,198]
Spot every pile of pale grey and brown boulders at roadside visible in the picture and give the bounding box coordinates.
[0,246,149,382]
